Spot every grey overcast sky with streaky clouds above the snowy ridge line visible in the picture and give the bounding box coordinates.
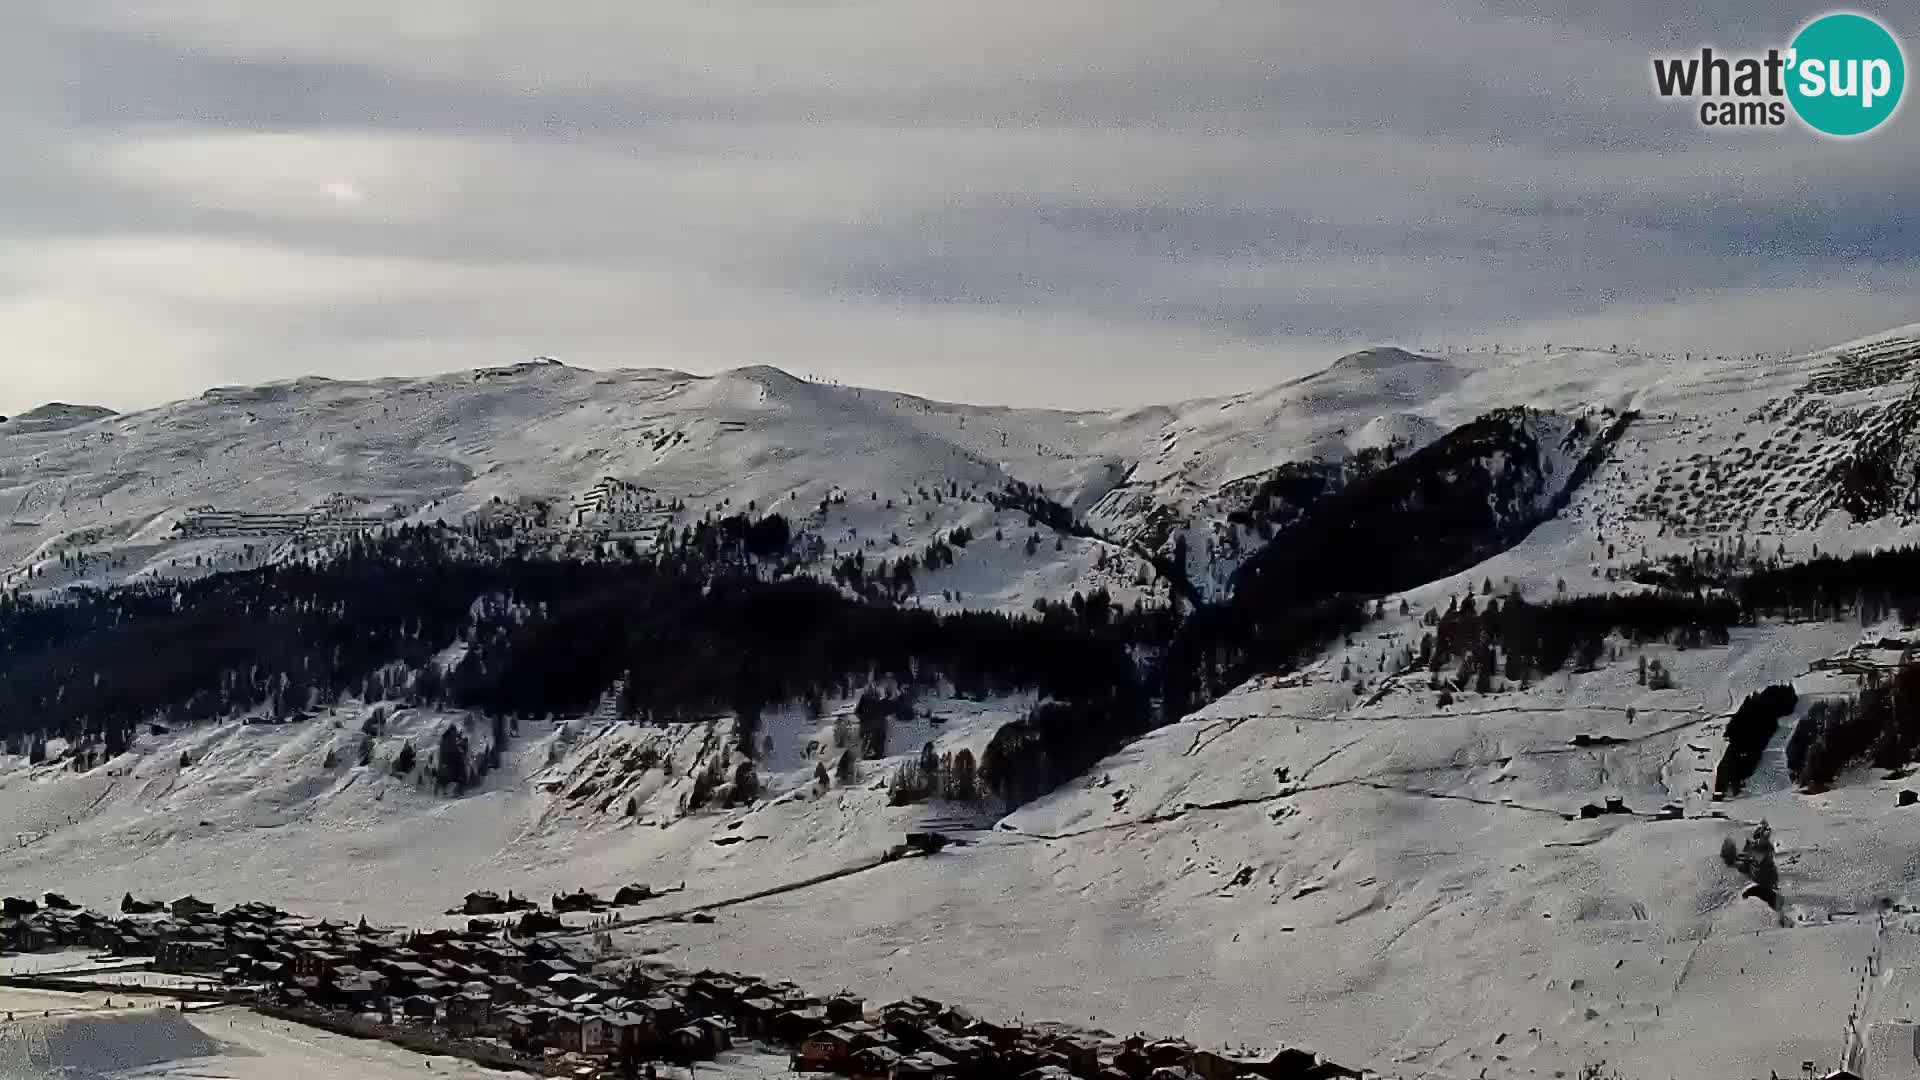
[0,0,1920,413]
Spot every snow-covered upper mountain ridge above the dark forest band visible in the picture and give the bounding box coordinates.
[0,342,1665,609]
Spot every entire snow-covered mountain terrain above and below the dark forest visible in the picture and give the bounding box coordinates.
[0,327,1920,1080]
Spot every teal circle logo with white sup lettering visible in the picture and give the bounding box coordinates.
[1788,12,1907,136]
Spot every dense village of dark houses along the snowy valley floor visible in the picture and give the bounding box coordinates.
[0,886,1361,1080]
